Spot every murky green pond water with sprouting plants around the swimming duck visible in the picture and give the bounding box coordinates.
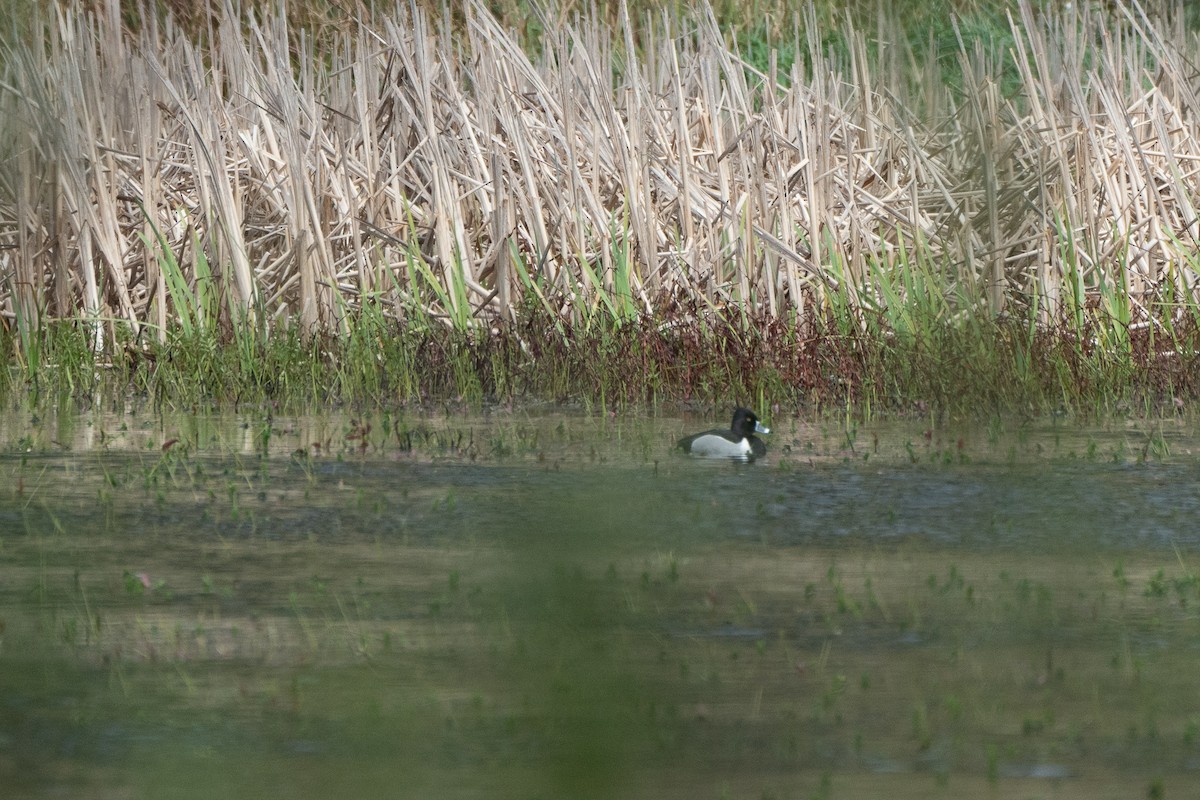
[0,409,1200,800]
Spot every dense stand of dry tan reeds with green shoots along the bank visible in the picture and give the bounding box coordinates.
[0,0,1200,405]
